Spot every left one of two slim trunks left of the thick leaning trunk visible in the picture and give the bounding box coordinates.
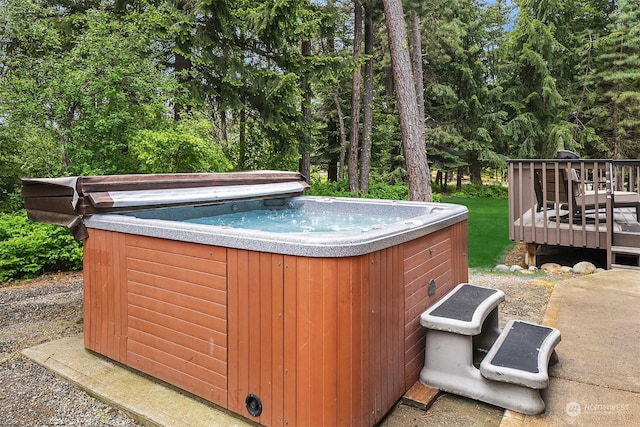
[348,0,362,193]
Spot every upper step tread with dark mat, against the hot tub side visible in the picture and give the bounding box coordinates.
[420,283,504,335]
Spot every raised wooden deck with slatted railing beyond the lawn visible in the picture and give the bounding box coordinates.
[509,159,640,269]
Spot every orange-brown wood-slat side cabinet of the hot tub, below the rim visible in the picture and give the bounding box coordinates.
[84,220,468,426]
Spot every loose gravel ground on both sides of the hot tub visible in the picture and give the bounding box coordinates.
[0,271,567,427]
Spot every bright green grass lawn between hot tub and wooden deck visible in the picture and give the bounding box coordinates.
[442,198,513,268]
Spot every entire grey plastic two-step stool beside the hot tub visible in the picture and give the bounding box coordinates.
[420,283,560,415]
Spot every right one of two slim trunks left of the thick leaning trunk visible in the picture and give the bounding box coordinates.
[360,5,374,194]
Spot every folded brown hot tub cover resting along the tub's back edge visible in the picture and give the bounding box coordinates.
[22,171,309,240]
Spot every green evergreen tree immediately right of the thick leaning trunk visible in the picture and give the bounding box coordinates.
[424,1,506,183]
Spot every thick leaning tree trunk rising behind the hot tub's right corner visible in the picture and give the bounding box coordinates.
[383,0,431,201]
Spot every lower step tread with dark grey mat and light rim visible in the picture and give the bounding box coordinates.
[480,320,560,388]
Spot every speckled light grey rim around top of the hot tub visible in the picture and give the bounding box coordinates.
[84,196,468,258]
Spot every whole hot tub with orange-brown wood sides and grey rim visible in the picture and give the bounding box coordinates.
[22,174,468,426]
